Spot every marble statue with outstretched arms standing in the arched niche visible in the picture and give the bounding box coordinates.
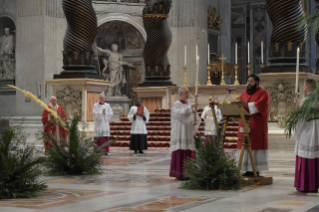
[97,44,133,96]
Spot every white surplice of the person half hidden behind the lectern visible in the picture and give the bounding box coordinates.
[201,105,223,135]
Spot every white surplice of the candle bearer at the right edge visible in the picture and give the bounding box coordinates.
[295,97,319,159]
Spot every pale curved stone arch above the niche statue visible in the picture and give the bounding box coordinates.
[97,13,147,42]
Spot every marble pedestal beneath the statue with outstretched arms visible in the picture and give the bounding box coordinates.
[105,96,131,121]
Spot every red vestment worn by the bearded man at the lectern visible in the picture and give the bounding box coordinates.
[237,87,270,150]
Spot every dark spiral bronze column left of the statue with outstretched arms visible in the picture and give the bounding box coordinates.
[54,0,100,78]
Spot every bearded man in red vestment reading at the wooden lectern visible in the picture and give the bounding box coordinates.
[237,74,270,176]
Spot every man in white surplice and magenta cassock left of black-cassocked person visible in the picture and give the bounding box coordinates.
[93,93,113,155]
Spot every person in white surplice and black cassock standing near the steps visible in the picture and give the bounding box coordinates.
[127,98,150,154]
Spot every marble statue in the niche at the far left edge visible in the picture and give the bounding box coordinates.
[0,28,15,78]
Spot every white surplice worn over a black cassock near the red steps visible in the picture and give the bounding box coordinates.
[127,106,150,134]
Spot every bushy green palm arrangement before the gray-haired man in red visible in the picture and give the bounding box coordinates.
[44,116,115,175]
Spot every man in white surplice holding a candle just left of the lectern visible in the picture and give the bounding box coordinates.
[169,87,201,180]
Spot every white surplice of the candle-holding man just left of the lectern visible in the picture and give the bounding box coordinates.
[170,100,201,152]
